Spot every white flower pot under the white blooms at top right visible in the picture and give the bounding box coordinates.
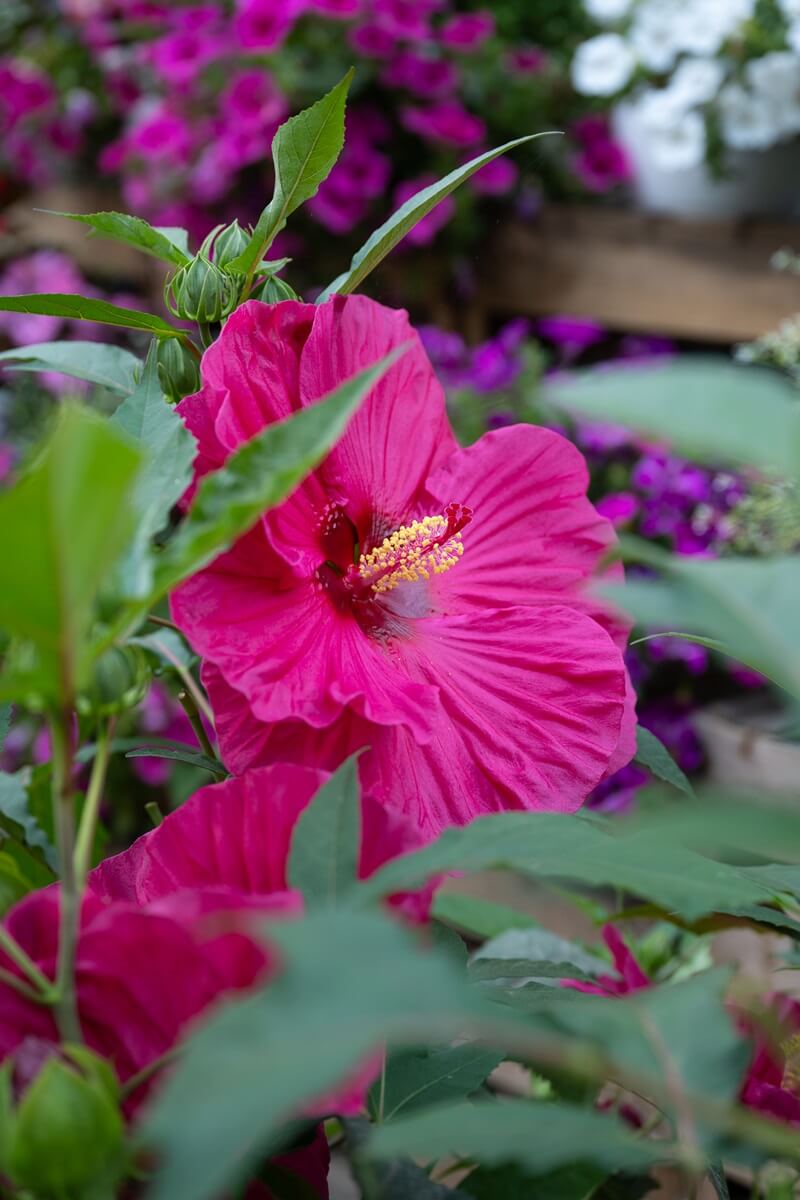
[612,103,800,218]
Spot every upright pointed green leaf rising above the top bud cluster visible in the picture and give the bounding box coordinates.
[231,70,353,275]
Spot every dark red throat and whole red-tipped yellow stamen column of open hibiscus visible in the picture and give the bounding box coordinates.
[317,504,473,602]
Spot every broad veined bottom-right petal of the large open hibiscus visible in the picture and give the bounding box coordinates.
[362,605,625,833]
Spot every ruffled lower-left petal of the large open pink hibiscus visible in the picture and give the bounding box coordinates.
[172,549,437,739]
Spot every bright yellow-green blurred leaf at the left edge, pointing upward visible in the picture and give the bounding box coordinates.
[0,406,140,700]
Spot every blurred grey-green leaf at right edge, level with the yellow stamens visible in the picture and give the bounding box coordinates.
[603,554,800,696]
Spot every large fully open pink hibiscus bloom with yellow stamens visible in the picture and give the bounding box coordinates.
[172,296,633,836]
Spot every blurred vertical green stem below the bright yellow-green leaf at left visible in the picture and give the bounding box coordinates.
[50,712,83,1042]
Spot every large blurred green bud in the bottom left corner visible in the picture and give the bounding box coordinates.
[0,1039,126,1200]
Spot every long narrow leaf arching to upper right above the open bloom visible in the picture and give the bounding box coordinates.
[317,133,546,304]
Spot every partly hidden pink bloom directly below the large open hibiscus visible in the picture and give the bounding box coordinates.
[89,763,433,920]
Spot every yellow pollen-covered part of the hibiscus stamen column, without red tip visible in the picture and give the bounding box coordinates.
[359,516,464,594]
